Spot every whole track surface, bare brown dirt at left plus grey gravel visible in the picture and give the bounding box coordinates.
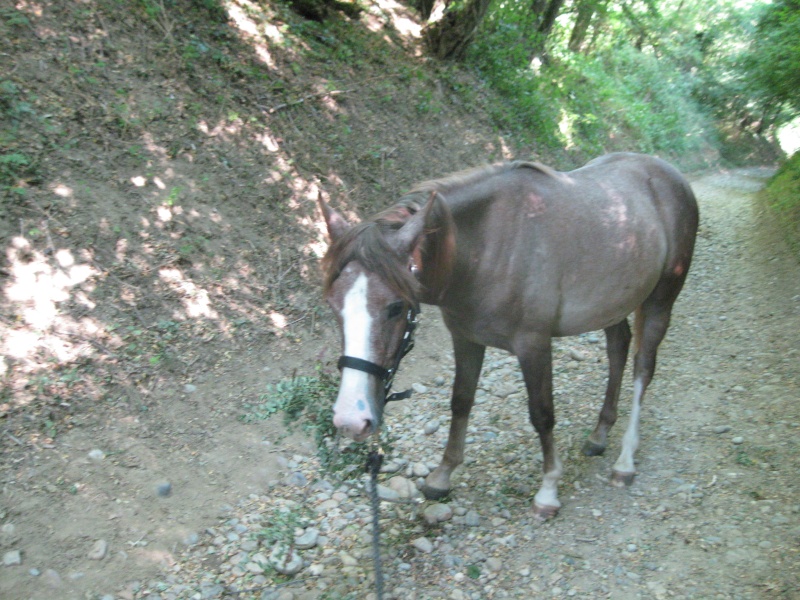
[0,169,800,600]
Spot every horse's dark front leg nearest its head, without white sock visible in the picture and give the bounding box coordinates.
[422,334,486,500]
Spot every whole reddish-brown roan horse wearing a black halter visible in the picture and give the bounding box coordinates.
[318,153,699,519]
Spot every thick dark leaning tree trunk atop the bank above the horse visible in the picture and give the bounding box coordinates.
[424,0,494,60]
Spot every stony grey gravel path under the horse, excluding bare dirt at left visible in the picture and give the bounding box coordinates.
[136,169,800,600]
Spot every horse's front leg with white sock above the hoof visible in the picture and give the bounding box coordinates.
[516,336,562,519]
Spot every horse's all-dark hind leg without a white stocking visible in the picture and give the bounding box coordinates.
[583,319,631,456]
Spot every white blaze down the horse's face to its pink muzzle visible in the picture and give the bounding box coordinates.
[333,273,376,441]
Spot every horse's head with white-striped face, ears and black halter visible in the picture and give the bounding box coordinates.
[318,194,442,441]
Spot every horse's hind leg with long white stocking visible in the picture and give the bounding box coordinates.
[611,301,672,487]
